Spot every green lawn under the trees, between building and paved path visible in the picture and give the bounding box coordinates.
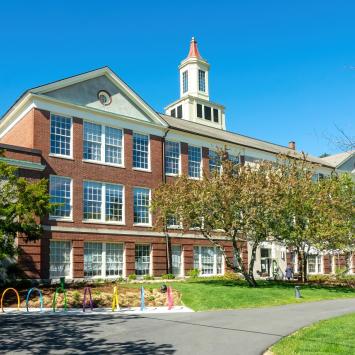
[120,279,355,311]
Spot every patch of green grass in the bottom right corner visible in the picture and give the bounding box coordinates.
[270,313,355,355]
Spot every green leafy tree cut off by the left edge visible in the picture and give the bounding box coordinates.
[0,156,51,260]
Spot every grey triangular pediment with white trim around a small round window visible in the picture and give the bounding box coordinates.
[31,68,166,126]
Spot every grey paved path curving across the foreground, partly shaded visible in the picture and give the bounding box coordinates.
[0,299,355,355]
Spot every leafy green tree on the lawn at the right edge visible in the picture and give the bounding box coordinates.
[275,156,354,281]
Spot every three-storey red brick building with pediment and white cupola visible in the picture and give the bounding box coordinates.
[0,39,354,279]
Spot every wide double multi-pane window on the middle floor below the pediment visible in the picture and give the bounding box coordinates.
[84,181,124,222]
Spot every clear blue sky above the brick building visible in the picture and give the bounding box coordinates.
[0,0,355,155]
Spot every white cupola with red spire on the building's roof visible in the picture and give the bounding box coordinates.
[165,37,226,129]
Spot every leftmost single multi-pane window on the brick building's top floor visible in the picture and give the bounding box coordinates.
[50,114,72,157]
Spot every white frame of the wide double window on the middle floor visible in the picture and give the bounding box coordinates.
[82,180,126,226]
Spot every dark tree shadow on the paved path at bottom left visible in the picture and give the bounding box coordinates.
[0,315,176,355]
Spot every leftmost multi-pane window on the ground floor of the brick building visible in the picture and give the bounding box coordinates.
[49,240,71,278]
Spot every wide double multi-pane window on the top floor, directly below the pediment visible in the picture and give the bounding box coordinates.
[83,122,123,165]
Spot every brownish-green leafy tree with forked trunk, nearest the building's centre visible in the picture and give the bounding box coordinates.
[152,151,281,286]
